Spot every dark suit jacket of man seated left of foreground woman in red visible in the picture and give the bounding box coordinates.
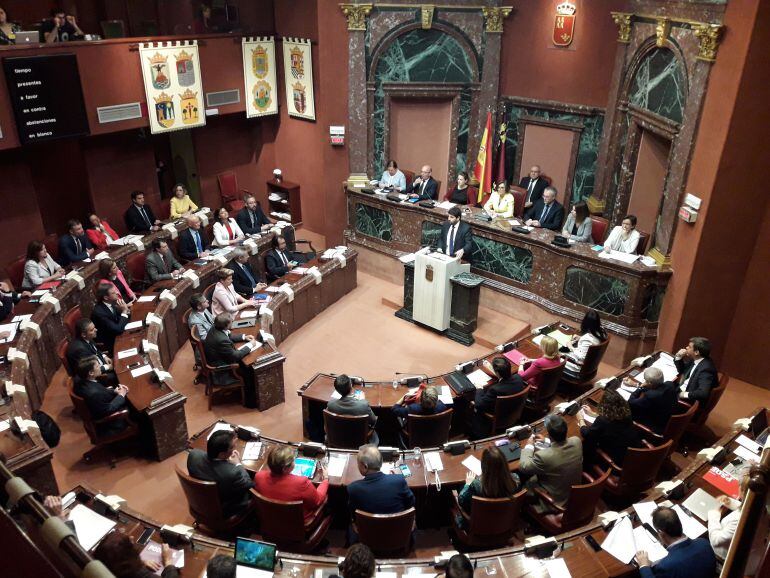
[187,450,254,517]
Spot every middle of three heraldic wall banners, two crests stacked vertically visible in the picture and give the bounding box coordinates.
[241,36,278,118]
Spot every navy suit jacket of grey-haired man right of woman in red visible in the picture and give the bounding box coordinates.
[348,472,414,514]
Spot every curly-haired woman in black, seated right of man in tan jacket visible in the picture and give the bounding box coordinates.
[577,389,642,466]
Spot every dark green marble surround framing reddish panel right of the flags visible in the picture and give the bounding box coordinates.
[505,102,604,203]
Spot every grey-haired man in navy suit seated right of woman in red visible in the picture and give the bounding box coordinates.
[348,445,414,514]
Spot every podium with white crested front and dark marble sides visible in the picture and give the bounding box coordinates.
[396,253,483,345]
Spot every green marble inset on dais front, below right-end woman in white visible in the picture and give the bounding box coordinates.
[564,267,628,315]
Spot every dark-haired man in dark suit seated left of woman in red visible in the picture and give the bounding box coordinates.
[187,430,254,518]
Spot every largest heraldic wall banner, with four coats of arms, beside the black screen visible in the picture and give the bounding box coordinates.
[139,40,206,134]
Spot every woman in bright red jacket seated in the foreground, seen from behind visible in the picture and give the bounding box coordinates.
[254,445,329,524]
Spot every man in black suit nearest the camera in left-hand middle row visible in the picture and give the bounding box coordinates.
[73,355,128,436]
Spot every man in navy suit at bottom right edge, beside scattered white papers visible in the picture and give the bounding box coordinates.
[636,507,717,578]
